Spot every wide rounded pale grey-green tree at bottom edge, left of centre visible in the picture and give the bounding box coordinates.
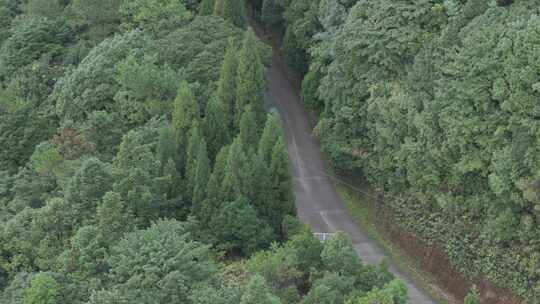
[108,220,217,304]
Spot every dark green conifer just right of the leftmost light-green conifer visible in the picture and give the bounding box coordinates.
[204,97,231,160]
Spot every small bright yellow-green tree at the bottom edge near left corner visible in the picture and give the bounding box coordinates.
[23,272,60,304]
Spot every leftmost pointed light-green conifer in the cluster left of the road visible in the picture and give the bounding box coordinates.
[172,81,200,172]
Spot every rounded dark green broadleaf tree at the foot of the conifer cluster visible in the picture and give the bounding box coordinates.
[211,198,273,256]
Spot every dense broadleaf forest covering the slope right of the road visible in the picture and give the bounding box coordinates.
[262,0,540,303]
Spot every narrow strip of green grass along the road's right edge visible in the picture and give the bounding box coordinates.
[336,184,456,304]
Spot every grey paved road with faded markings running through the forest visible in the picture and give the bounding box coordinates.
[268,54,435,304]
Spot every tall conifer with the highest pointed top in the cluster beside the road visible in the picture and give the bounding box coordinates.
[236,29,266,125]
